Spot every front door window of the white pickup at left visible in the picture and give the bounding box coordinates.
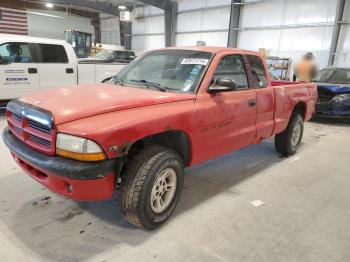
[0,43,33,64]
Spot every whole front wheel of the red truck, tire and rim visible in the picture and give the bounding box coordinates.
[121,146,184,230]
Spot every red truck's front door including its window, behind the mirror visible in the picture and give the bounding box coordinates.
[196,54,256,162]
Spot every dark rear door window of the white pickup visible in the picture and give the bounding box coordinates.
[39,44,68,63]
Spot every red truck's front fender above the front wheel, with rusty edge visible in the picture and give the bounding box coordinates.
[57,100,196,164]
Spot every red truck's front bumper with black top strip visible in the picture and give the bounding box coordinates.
[2,128,119,201]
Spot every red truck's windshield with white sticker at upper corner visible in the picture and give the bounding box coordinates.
[117,50,212,92]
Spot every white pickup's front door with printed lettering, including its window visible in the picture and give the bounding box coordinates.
[0,42,40,100]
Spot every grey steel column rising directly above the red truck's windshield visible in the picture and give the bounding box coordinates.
[164,0,178,47]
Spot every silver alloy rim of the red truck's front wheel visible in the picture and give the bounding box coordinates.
[150,167,177,214]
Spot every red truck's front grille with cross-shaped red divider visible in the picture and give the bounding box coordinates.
[6,101,56,155]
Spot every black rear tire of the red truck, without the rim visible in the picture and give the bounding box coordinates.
[275,113,304,157]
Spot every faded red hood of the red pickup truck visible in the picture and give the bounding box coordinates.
[20,84,196,125]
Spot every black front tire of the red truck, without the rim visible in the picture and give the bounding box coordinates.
[121,146,184,230]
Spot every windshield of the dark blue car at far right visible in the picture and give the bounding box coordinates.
[314,69,350,84]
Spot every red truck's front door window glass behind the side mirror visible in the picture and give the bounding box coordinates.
[213,55,248,90]
